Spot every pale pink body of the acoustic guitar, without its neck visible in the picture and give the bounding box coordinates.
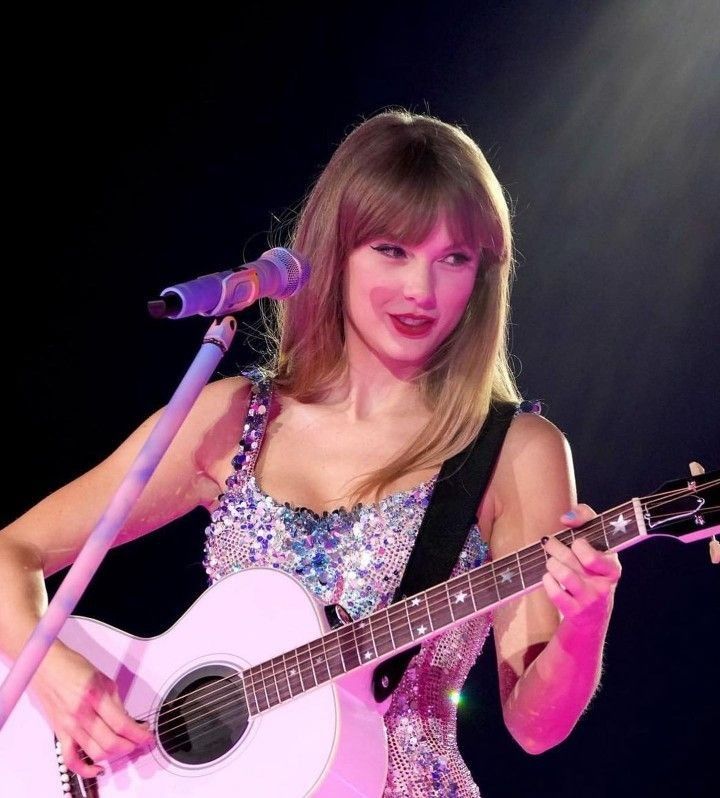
[0,568,387,798]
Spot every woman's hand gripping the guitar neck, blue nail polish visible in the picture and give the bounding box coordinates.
[543,504,621,631]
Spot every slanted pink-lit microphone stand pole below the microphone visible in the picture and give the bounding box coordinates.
[0,316,237,730]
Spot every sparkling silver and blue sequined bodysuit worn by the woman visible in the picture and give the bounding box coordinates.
[204,382,500,798]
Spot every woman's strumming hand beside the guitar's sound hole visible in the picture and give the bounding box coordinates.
[30,641,153,778]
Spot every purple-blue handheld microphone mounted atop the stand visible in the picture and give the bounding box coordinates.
[147,247,310,319]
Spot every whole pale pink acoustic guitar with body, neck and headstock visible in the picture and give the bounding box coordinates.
[0,471,720,798]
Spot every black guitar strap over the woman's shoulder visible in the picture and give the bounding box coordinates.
[373,402,517,702]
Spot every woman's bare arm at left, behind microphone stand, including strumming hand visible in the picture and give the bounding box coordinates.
[0,378,248,777]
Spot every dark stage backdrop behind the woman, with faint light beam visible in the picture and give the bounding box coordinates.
[2,0,720,798]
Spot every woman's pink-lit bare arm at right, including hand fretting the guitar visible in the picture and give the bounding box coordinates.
[490,416,620,754]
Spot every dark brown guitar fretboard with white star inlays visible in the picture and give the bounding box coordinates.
[240,500,645,715]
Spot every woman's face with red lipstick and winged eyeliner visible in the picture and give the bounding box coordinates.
[343,221,479,371]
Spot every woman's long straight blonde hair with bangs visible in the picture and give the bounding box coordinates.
[265,109,519,498]
